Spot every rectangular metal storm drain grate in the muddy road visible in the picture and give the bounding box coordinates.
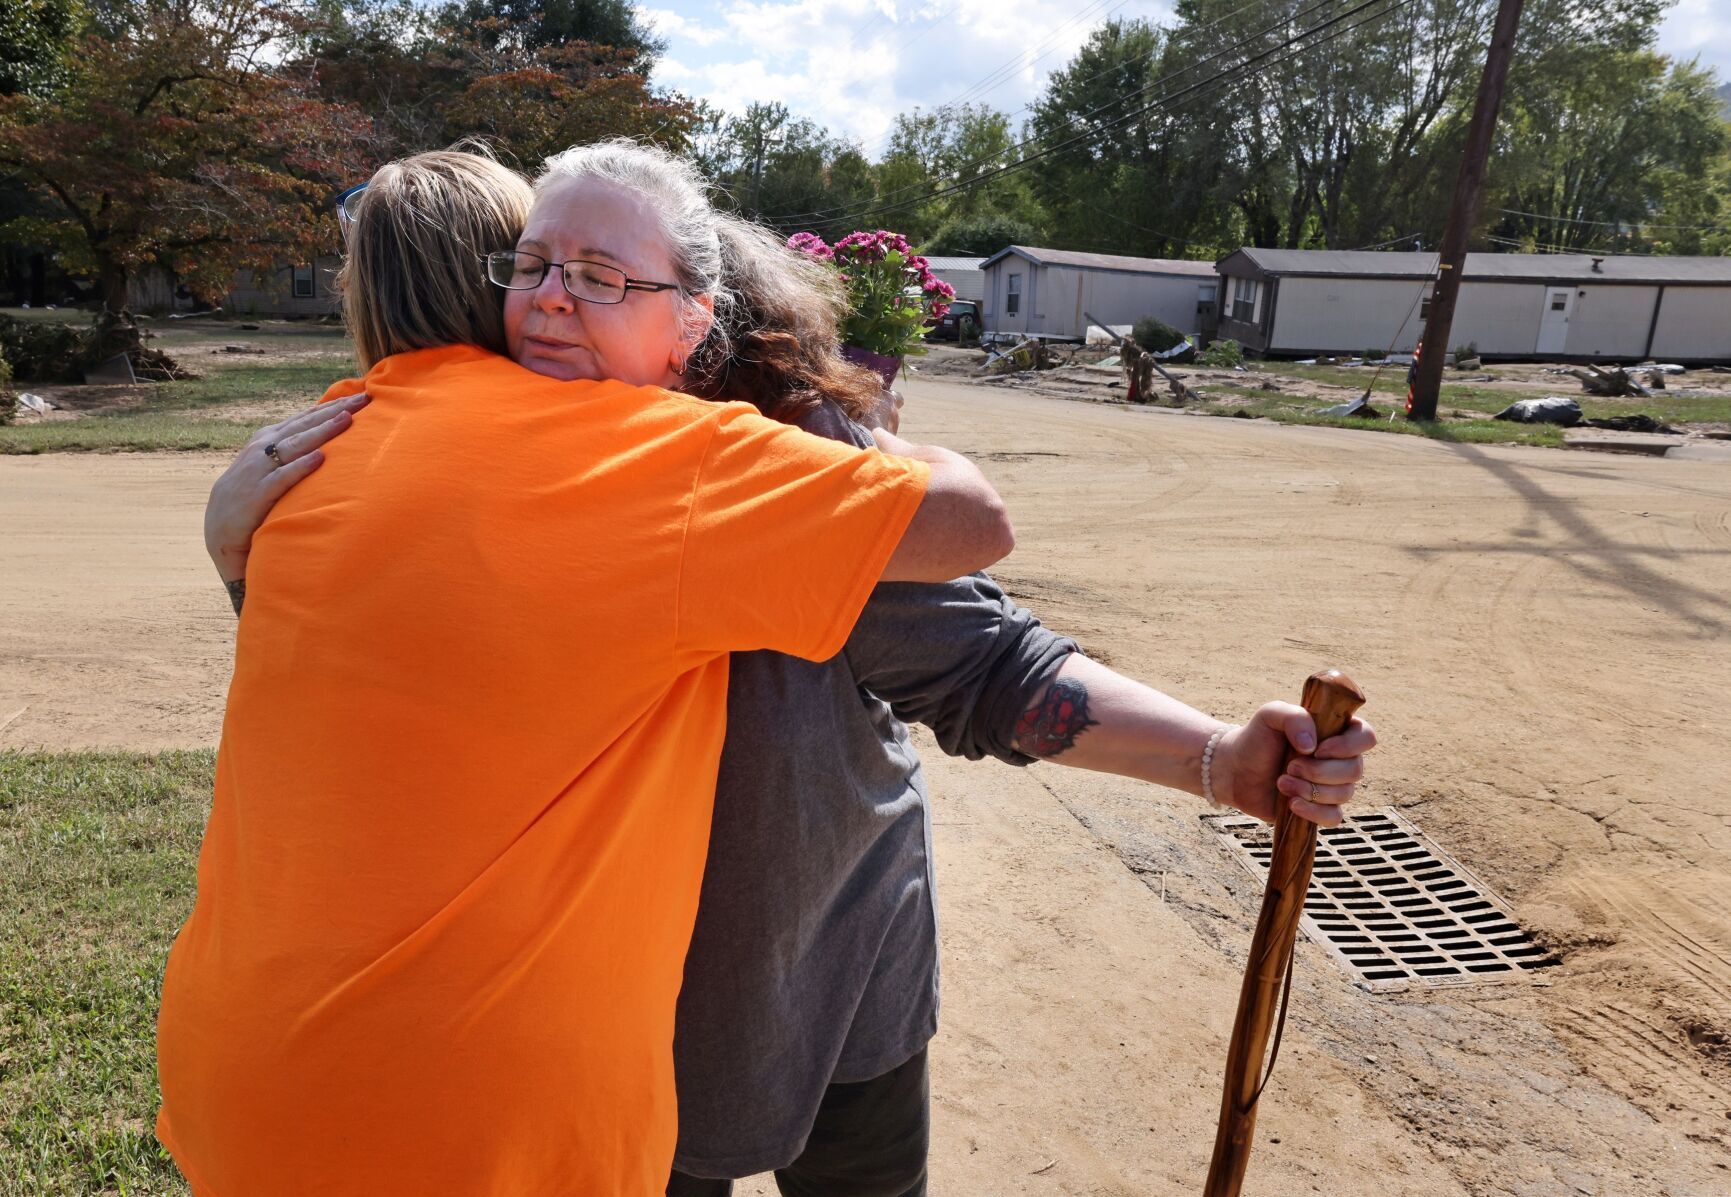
[1203,810,1556,991]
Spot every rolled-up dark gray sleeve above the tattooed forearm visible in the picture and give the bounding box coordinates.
[845,574,1078,765]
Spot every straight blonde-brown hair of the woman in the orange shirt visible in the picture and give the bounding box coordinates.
[338,149,533,370]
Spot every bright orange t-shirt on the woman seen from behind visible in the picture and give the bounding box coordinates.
[158,348,928,1197]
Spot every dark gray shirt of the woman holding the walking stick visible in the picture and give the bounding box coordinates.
[673,406,1075,1176]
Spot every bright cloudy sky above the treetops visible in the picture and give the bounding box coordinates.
[642,0,1731,157]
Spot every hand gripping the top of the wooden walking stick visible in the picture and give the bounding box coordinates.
[1213,702,1376,827]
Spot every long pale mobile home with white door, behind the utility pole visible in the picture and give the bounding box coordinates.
[1219,249,1731,362]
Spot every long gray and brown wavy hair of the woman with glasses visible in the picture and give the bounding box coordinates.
[535,138,881,424]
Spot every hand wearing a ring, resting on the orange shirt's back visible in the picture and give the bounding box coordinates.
[204,393,367,581]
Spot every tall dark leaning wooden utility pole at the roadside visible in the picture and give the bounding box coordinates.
[1407,0,1522,420]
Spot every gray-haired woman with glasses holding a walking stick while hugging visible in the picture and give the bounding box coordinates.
[213,142,1373,1197]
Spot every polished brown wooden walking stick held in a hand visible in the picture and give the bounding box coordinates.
[1203,669,1364,1197]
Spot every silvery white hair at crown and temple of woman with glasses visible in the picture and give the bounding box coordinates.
[535,137,737,355]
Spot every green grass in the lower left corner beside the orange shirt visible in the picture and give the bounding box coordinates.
[0,749,215,1197]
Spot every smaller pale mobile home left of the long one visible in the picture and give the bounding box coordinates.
[981,246,1220,341]
